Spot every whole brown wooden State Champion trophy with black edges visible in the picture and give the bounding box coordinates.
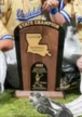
[15,20,64,97]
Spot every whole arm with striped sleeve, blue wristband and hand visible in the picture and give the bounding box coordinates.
[43,0,72,25]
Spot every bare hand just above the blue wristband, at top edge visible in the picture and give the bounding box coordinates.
[42,0,59,11]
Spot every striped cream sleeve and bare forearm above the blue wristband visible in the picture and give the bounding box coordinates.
[50,3,72,25]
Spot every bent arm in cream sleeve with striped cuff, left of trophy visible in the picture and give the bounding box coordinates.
[0,20,13,51]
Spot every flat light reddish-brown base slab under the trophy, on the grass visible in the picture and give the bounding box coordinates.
[15,90,64,98]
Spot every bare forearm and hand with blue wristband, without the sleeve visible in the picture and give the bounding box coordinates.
[43,0,66,25]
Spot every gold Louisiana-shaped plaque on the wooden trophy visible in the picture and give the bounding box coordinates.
[26,33,51,56]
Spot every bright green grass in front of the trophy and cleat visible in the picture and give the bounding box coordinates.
[0,90,81,117]
